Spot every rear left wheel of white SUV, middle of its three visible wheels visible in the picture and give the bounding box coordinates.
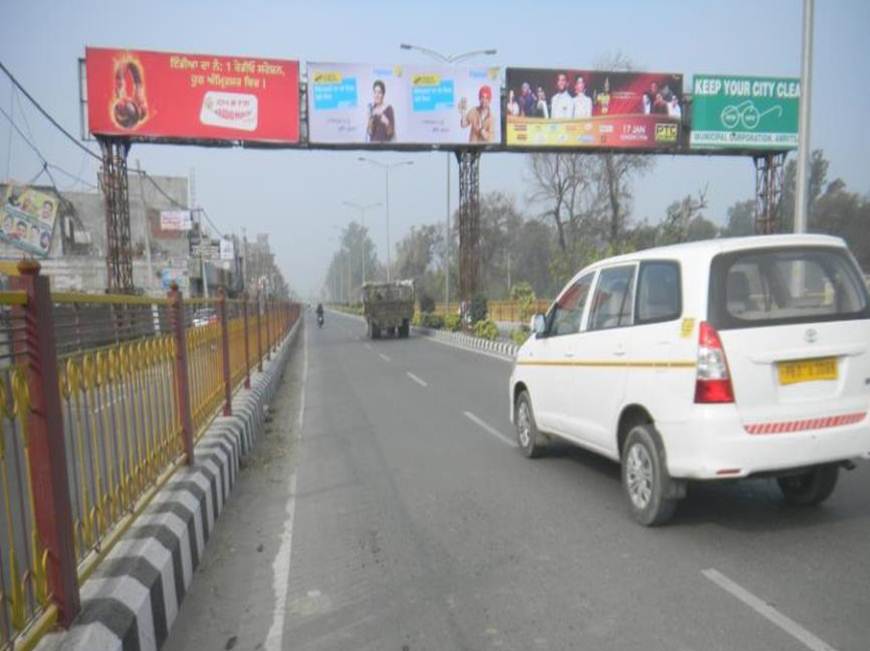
[622,425,677,527]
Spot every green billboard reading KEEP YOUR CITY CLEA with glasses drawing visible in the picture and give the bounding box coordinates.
[690,75,800,150]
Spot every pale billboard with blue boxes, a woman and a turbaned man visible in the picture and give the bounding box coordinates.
[308,63,502,146]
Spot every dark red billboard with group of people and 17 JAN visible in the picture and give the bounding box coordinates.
[505,68,683,149]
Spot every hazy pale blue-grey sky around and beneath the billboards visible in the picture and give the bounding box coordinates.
[0,0,870,292]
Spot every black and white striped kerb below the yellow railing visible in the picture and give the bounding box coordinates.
[37,322,301,651]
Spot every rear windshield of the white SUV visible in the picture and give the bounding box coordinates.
[708,247,870,329]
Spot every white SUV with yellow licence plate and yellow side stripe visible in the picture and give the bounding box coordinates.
[510,235,870,525]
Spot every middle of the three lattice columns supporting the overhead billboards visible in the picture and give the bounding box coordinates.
[456,150,480,301]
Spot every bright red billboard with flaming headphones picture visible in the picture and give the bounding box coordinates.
[86,47,299,143]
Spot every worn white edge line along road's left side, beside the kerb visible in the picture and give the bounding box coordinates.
[263,329,308,651]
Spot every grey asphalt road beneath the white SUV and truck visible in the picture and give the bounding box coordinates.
[165,314,870,651]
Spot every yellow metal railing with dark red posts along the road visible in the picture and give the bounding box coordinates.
[0,278,299,651]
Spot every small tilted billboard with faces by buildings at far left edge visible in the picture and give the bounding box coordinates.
[0,184,58,258]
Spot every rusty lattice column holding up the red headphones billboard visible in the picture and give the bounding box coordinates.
[99,138,133,294]
